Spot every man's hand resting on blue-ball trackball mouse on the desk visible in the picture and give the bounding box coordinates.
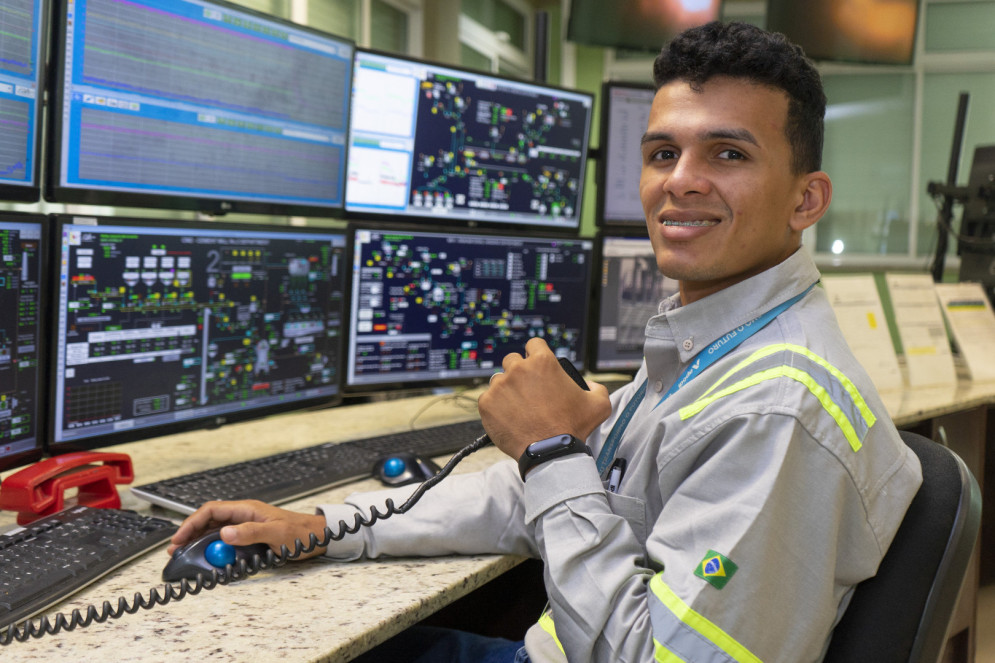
[167,500,325,559]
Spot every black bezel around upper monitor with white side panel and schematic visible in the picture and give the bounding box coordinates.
[343,47,597,235]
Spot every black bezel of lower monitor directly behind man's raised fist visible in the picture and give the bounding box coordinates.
[342,222,596,400]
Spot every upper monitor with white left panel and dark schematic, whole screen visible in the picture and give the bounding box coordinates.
[345,50,594,231]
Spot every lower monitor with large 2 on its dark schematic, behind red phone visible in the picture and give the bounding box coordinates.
[50,216,347,453]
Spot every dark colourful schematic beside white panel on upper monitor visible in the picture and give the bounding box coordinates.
[410,75,588,217]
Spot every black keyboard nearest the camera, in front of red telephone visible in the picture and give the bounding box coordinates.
[0,506,176,628]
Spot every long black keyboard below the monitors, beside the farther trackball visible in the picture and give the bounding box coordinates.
[131,419,484,513]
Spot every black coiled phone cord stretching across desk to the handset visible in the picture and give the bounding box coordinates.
[0,435,491,645]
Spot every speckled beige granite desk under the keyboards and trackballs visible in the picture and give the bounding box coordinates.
[0,383,995,663]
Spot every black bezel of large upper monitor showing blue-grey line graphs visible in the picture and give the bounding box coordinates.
[43,0,356,218]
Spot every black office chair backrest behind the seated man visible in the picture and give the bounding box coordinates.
[824,431,981,663]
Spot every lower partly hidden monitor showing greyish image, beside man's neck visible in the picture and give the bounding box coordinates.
[590,230,677,373]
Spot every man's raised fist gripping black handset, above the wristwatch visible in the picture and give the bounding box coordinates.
[478,338,611,460]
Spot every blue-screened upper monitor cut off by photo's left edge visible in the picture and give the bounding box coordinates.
[0,0,48,202]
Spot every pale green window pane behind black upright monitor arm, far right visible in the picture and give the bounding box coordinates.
[916,73,995,255]
